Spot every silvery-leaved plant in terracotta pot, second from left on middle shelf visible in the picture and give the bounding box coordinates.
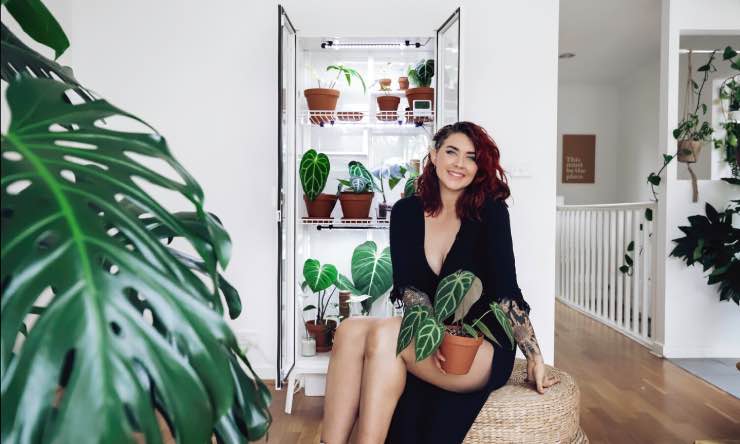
[337,160,378,219]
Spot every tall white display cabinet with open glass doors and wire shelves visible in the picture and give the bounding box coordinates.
[275,6,460,413]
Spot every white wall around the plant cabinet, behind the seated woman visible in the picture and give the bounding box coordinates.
[2,0,558,379]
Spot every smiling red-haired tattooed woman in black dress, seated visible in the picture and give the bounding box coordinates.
[322,122,559,444]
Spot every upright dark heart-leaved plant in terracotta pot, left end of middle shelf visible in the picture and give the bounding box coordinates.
[299,149,337,219]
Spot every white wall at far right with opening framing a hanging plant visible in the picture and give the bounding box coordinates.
[656,0,740,357]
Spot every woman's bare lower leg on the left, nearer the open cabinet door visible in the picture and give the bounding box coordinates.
[321,317,379,444]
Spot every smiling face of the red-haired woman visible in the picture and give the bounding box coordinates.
[429,133,478,191]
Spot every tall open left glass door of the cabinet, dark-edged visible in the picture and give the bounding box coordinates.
[275,6,296,388]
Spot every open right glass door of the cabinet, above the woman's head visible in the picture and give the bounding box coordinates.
[435,8,460,129]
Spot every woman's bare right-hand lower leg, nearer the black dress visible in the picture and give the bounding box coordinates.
[356,318,406,444]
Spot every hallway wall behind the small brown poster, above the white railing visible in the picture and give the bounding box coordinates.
[556,83,626,205]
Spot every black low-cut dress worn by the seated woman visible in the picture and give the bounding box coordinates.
[385,196,529,444]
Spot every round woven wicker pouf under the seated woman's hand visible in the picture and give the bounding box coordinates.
[463,359,588,444]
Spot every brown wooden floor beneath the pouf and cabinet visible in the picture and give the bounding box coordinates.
[259,302,740,444]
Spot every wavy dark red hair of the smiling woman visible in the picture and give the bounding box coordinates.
[416,122,511,220]
